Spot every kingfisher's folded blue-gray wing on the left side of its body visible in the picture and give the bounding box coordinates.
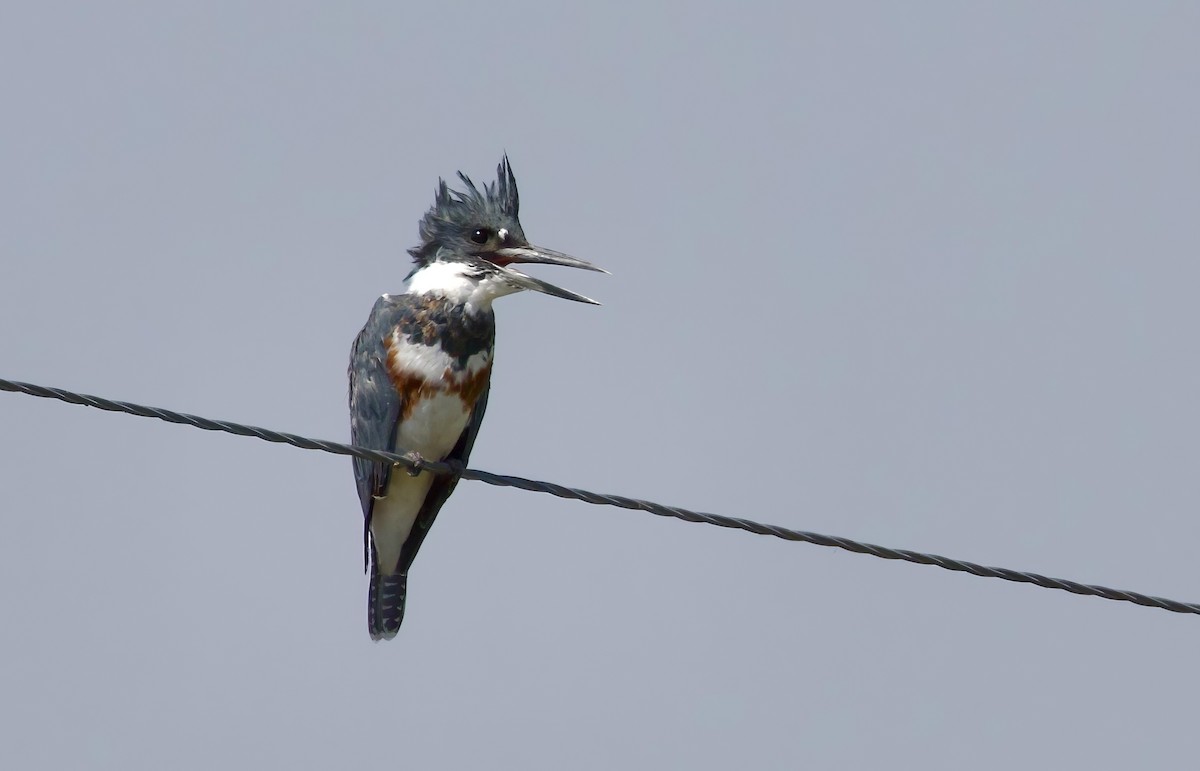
[349,294,406,525]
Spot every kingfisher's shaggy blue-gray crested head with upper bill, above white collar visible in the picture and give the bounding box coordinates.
[408,156,608,275]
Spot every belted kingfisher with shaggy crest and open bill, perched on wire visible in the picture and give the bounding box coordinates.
[349,156,607,640]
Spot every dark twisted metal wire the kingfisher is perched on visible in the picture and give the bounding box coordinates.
[7,378,1200,615]
